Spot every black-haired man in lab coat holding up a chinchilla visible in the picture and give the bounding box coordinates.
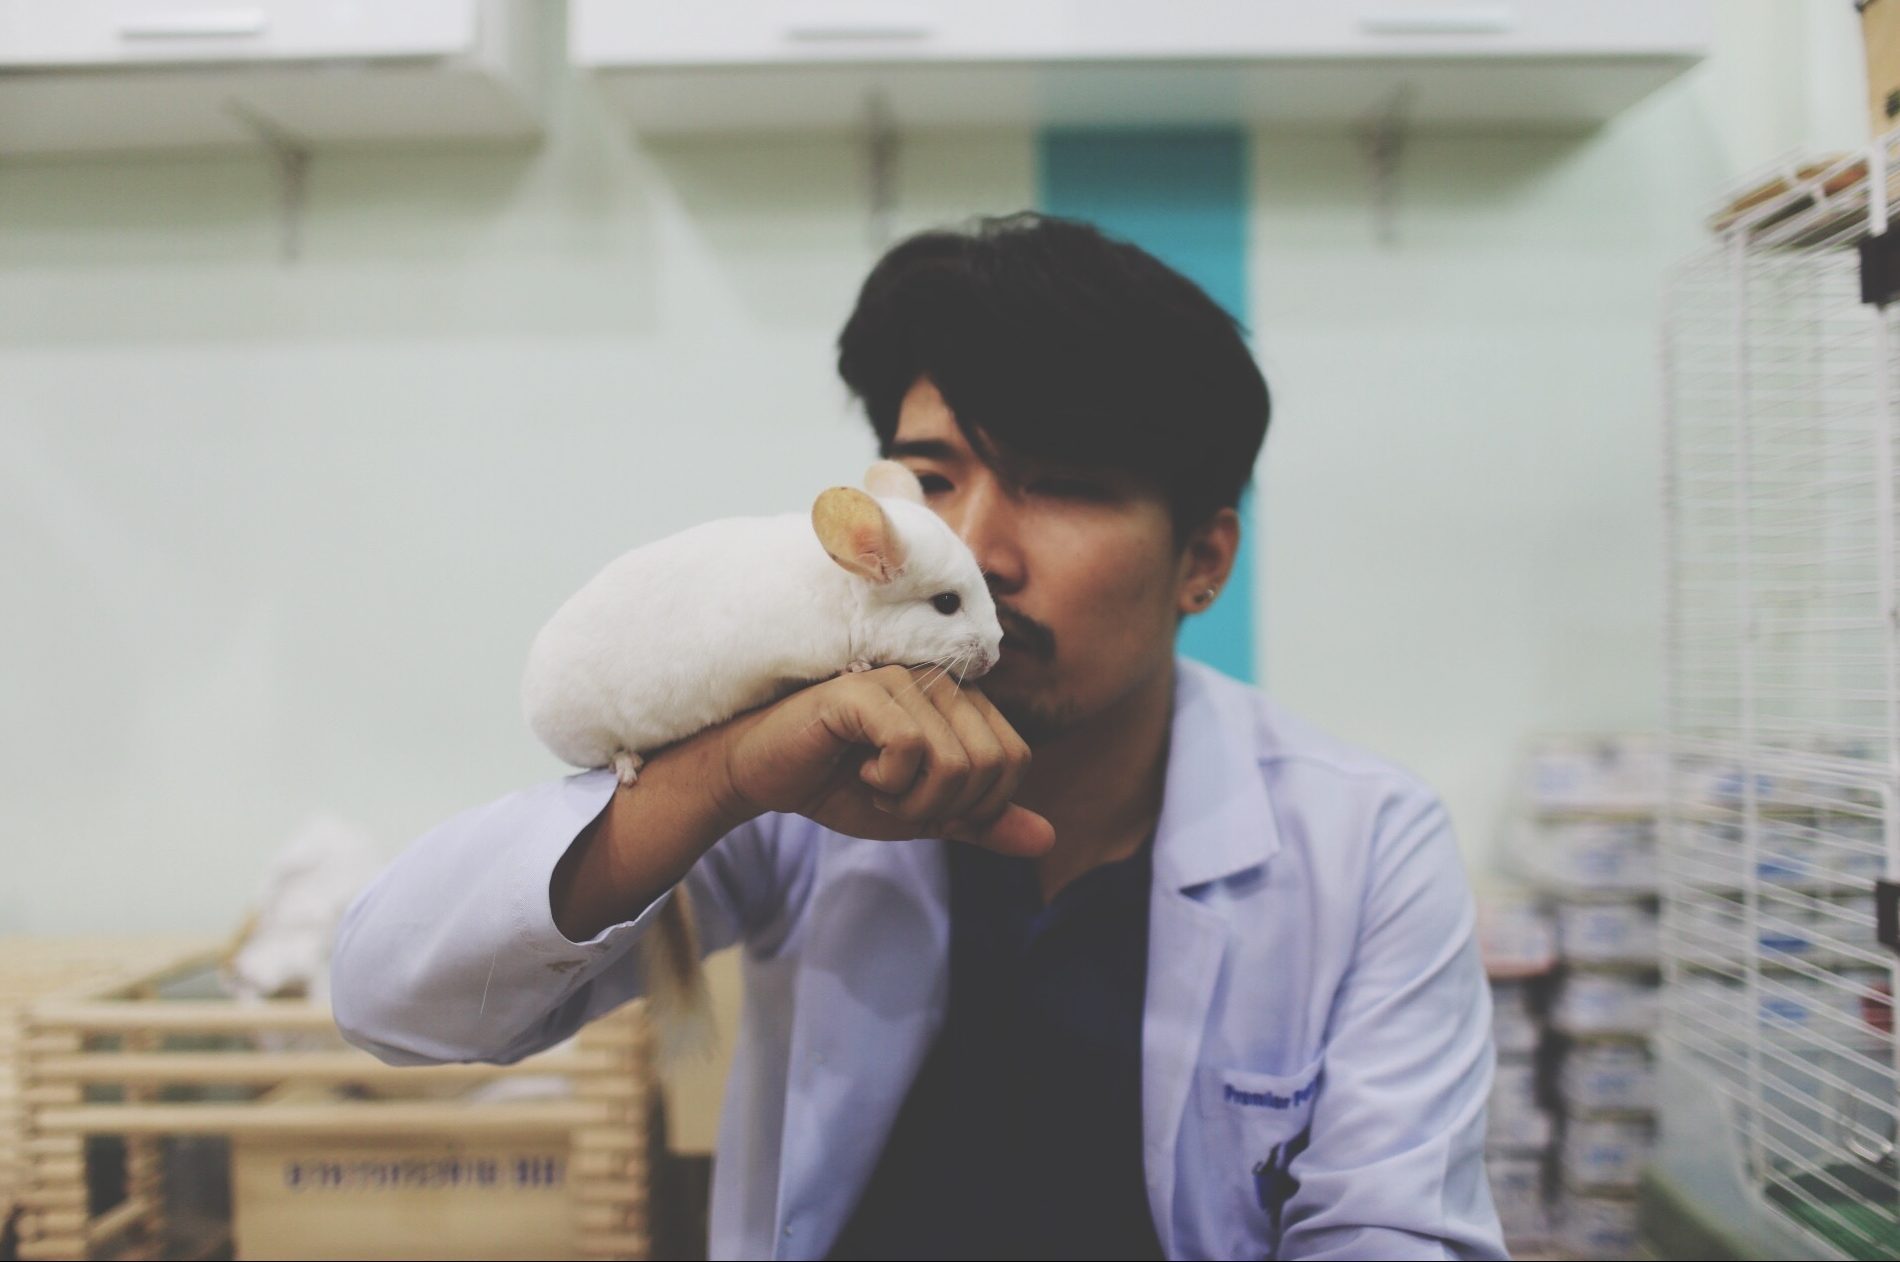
[333,215,1505,1258]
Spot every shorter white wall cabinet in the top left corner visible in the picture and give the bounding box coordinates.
[0,0,551,156]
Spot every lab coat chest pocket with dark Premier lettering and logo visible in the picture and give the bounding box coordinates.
[1195,1059,1321,1256]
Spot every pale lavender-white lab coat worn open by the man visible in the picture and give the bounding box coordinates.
[333,660,1505,1258]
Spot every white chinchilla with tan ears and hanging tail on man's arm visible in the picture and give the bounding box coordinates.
[521,460,1003,1051]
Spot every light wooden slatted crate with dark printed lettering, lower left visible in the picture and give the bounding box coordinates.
[15,952,654,1260]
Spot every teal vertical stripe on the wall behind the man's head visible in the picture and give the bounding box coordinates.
[1036,127,1256,682]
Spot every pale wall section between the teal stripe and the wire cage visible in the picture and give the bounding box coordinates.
[1250,0,1868,867]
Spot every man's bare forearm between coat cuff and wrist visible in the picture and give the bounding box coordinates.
[547,726,751,943]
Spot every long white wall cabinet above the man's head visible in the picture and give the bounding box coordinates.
[568,0,1712,135]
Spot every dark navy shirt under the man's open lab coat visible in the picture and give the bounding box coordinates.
[830,838,1163,1258]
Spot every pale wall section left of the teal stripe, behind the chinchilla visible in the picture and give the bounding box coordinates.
[0,17,1034,931]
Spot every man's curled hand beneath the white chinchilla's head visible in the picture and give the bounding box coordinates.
[724,665,1055,855]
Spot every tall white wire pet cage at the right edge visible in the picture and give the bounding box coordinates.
[1661,133,1900,1258]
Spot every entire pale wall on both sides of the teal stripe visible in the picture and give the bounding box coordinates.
[0,0,1860,931]
